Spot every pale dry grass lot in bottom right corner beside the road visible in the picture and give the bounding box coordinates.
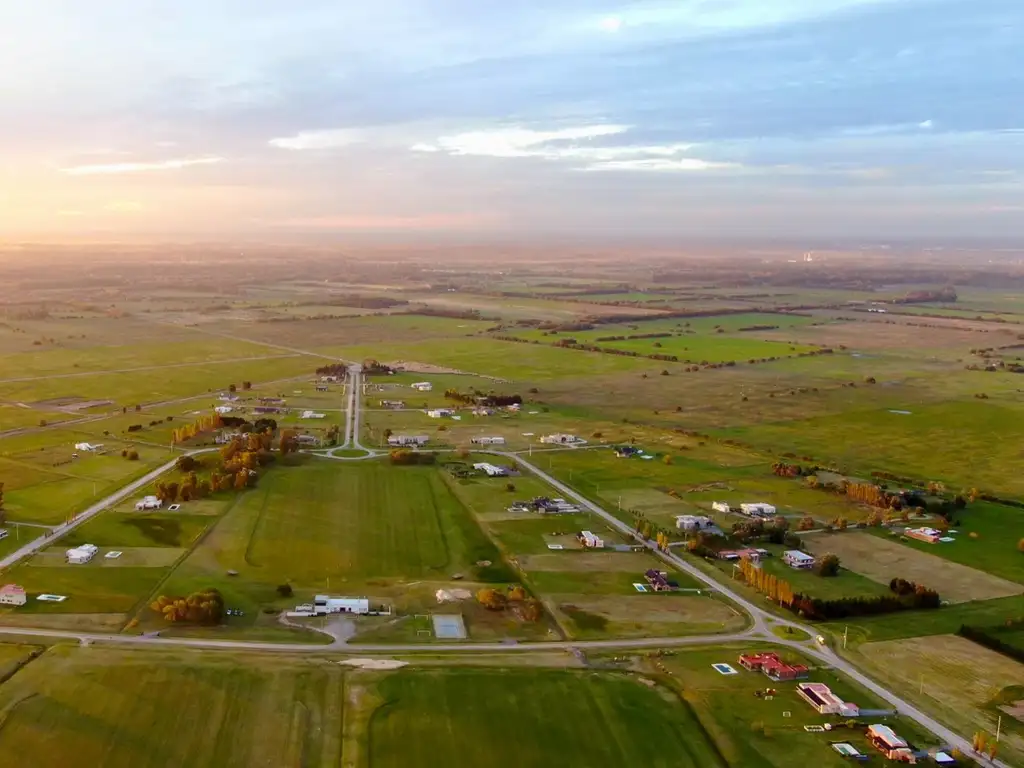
[857,635,1024,765]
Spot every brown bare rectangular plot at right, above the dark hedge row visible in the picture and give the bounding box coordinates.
[804,531,1024,603]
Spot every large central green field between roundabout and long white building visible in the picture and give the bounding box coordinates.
[151,458,514,626]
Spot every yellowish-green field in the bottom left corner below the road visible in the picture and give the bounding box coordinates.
[0,646,347,768]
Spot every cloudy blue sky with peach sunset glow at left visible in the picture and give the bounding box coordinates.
[0,0,1024,241]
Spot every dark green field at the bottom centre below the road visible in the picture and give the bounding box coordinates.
[369,669,729,768]
